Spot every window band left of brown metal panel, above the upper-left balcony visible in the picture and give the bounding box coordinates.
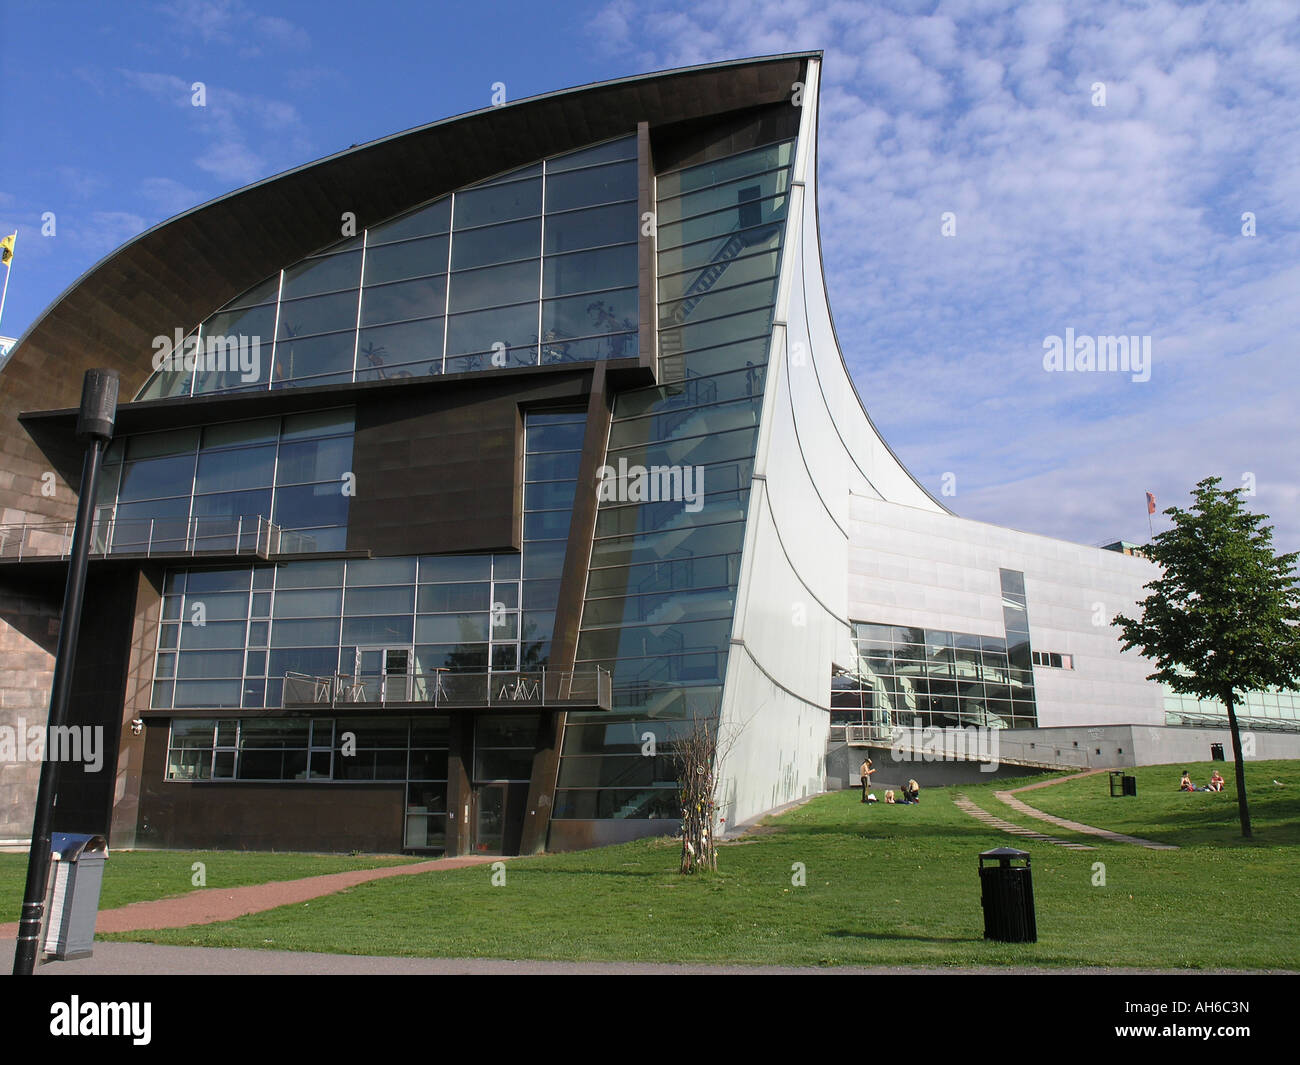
[95,408,354,553]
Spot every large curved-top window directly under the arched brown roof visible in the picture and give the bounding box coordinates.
[137,137,640,399]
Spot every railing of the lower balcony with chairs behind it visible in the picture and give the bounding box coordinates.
[283,666,614,710]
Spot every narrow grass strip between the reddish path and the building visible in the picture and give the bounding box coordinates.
[0,850,417,923]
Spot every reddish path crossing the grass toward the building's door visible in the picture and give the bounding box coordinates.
[0,854,508,936]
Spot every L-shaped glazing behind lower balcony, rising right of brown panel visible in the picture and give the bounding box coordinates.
[147,411,585,709]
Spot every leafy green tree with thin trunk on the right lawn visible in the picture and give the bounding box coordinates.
[1113,477,1300,839]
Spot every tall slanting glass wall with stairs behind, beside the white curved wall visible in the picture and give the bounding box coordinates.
[553,140,794,819]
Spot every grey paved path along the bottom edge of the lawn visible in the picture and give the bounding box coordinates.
[0,939,1282,977]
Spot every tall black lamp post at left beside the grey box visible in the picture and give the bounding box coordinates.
[13,369,118,977]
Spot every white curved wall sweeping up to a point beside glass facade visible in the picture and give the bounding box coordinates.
[719,60,945,826]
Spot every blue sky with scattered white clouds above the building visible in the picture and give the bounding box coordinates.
[0,0,1300,559]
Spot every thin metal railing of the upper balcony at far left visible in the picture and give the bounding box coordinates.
[0,515,316,562]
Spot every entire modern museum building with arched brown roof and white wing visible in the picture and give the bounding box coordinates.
[0,53,1300,854]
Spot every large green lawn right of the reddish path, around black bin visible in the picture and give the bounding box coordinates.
[111,762,1300,969]
